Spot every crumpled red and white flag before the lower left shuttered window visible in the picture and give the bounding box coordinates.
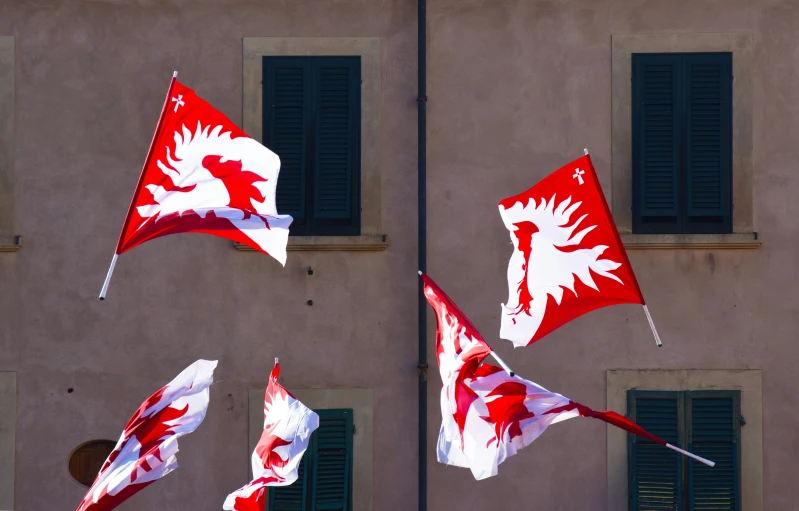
[222,359,319,511]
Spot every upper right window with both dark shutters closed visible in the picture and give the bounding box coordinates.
[632,53,732,234]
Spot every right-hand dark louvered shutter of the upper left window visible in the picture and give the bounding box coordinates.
[314,57,361,220]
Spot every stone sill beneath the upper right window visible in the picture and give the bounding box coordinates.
[621,232,760,250]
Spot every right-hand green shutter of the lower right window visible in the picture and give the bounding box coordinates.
[686,391,741,511]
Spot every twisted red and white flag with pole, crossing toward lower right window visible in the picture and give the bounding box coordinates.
[422,275,712,480]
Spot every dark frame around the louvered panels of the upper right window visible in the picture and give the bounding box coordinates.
[630,51,735,235]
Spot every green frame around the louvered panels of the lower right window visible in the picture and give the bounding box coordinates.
[626,389,743,511]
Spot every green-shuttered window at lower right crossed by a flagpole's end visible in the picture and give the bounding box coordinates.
[627,390,742,511]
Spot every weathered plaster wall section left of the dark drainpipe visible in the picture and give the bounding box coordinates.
[0,0,417,511]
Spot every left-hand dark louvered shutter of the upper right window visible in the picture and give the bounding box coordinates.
[632,54,681,232]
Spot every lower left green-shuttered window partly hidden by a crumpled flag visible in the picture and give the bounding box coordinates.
[267,409,354,511]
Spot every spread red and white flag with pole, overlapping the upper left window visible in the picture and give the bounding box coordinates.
[100,77,292,298]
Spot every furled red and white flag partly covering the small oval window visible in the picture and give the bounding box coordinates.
[78,360,216,511]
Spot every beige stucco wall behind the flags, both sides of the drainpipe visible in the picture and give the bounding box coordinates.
[0,0,799,511]
